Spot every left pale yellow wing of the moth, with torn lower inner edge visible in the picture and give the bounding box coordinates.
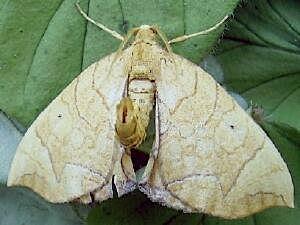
[8,51,135,202]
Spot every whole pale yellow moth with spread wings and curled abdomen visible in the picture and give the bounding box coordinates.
[8,5,294,218]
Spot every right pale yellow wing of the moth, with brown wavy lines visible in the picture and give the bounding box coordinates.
[139,52,294,218]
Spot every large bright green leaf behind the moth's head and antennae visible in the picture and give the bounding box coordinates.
[0,0,238,126]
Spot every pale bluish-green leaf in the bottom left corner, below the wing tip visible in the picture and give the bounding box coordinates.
[0,186,87,225]
